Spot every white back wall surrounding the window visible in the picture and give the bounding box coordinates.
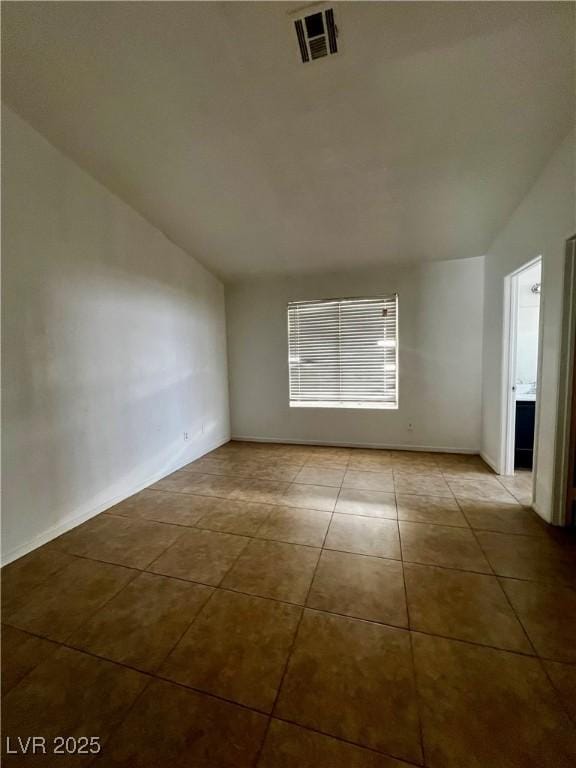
[226,257,484,451]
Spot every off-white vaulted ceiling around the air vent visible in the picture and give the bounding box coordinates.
[2,2,574,279]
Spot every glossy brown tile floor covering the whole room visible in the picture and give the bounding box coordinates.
[2,442,576,768]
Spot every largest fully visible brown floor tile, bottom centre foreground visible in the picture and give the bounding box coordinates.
[275,609,421,762]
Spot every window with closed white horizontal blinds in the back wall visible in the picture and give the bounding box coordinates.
[288,295,398,408]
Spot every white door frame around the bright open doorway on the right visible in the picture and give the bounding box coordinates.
[499,255,543,477]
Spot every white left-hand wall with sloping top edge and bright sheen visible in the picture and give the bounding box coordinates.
[2,107,229,562]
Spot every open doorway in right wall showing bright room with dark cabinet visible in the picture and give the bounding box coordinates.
[501,257,542,504]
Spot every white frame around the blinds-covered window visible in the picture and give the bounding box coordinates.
[286,292,400,411]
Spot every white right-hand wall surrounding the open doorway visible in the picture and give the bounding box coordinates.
[482,135,576,522]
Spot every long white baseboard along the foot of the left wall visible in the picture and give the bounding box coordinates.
[2,437,230,566]
